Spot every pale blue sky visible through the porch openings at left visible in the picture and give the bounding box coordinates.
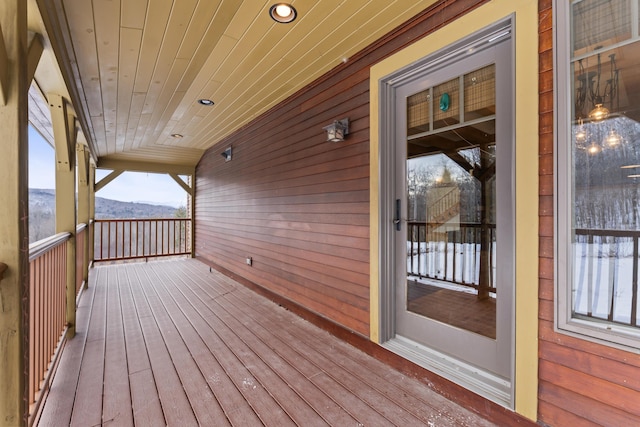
[29,126,187,207]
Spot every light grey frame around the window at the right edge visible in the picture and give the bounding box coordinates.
[553,0,640,352]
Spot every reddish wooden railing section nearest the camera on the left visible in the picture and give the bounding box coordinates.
[28,233,70,420]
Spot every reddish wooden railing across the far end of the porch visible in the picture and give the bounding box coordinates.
[94,218,191,262]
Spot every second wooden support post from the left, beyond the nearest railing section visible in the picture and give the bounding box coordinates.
[47,93,77,338]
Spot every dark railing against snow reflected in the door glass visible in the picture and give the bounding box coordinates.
[407,221,496,292]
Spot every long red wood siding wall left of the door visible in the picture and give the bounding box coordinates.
[195,0,484,336]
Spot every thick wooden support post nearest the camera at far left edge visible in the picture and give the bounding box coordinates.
[0,0,29,426]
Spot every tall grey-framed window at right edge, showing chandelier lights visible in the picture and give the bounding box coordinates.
[556,0,640,348]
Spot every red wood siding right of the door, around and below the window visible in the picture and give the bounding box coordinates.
[538,0,640,426]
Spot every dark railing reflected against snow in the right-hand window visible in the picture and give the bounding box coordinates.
[573,229,640,327]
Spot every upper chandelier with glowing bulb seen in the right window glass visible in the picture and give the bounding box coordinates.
[575,53,620,122]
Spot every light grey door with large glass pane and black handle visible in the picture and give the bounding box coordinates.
[380,23,515,403]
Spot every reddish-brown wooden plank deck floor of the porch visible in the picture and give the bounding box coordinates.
[39,259,498,426]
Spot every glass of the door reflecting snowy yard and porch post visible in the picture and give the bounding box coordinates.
[406,65,498,339]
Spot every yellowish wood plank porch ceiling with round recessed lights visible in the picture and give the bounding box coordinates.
[29,0,435,171]
